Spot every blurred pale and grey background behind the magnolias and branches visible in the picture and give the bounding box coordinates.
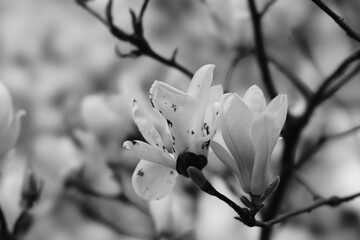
[0,0,360,240]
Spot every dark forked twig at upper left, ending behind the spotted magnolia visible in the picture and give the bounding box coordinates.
[76,0,194,78]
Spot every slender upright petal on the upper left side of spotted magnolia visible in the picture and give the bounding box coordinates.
[133,99,164,148]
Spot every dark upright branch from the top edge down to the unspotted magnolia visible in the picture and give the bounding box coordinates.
[248,0,277,98]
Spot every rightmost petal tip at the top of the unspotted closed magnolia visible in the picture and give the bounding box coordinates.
[266,94,288,129]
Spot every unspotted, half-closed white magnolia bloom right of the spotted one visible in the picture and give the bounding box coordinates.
[211,85,288,203]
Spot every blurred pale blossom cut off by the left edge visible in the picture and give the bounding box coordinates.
[0,80,25,167]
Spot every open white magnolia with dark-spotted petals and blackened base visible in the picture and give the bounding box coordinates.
[124,65,222,200]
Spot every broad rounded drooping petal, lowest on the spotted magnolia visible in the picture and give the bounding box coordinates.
[132,160,178,200]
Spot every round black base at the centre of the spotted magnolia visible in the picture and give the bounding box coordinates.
[176,152,207,177]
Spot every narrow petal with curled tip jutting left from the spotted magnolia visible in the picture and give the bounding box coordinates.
[123,140,176,169]
